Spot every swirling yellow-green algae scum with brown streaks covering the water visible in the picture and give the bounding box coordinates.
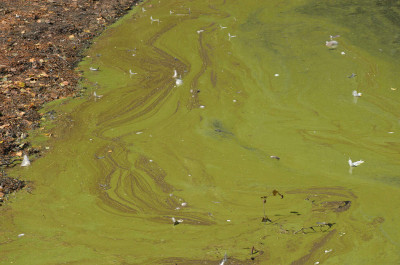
[0,0,400,264]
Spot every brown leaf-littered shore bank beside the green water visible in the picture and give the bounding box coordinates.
[0,0,140,202]
